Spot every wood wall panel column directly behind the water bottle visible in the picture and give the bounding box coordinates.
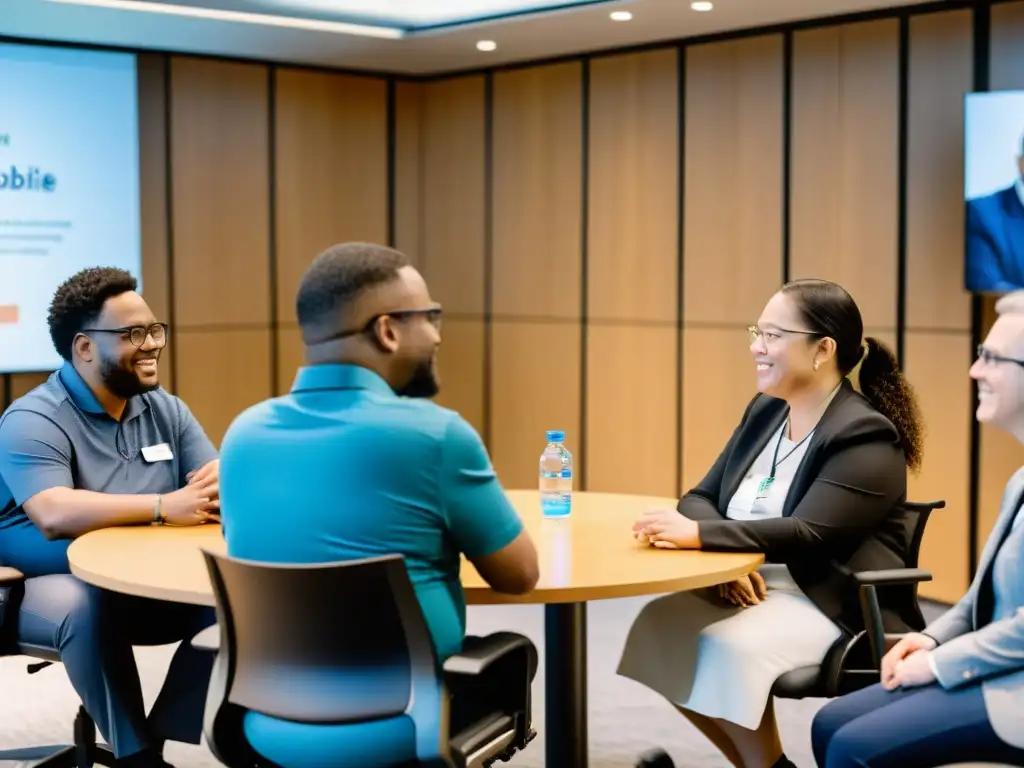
[489,61,584,487]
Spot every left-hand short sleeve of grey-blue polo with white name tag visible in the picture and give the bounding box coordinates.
[0,411,75,507]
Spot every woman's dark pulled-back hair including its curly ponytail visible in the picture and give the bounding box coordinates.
[782,280,925,472]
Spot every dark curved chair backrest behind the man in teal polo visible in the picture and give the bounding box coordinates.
[203,551,438,724]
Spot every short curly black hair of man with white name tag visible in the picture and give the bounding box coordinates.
[46,266,138,360]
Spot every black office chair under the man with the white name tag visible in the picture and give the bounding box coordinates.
[0,564,115,768]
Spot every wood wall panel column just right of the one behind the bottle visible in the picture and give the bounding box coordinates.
[589,48,680,496]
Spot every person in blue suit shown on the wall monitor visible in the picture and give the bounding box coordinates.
[967,140,1024,293]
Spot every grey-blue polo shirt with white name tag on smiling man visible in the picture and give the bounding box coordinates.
[0,362,217,575]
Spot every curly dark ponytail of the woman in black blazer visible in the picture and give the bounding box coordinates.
[859,336,924,472]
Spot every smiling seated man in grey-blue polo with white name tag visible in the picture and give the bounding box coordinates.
[0,267,219,768]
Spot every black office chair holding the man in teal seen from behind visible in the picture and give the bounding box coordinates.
[194,552,537,768]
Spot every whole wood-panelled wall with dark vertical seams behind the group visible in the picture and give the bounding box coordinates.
[0,1,1024,601]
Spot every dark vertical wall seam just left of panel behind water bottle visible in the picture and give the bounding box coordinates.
[481,72,495,451]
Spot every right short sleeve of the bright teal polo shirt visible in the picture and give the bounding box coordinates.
[440,414,522,557]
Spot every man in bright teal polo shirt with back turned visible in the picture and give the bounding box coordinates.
[220,243,538,764]
